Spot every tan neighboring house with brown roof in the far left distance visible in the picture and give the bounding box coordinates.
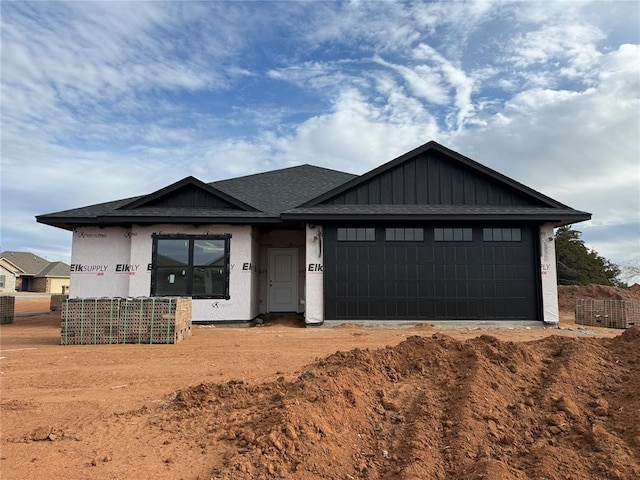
[0,251,70,293]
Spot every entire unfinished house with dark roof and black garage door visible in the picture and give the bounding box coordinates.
[37,142,591,325]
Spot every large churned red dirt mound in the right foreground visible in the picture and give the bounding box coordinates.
[152,327,640,480]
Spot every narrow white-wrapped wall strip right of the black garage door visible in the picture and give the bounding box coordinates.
[540,223,560,324]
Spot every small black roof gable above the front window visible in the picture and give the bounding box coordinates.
[117,177,255,211]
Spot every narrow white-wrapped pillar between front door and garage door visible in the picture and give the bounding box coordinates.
[304,225,324,325]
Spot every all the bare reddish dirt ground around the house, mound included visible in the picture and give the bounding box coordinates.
[0,286,640,480]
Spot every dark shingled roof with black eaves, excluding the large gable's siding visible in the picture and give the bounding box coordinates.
[37,142,591,229]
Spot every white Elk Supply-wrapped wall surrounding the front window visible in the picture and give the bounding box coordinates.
[70,225,258,321]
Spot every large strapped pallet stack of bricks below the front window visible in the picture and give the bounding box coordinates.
[61,297,191,345]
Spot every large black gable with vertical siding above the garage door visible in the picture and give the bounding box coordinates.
[301,142,566,208]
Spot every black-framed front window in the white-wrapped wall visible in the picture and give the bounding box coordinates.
[151,235,231,299]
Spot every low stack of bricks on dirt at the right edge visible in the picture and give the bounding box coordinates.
[576,299,640,329]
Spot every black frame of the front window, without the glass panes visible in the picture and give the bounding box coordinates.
[150,233,231,300]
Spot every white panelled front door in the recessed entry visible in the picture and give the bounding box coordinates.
[269,248,298,312]
